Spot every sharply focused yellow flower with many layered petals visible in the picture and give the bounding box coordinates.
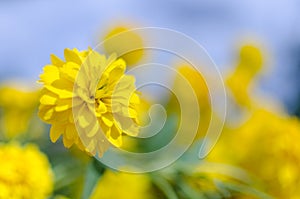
[39,49,139,156]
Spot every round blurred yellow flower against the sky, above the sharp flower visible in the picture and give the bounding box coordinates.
[103,26,145,66]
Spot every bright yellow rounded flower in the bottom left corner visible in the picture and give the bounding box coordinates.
[0,143,53,199]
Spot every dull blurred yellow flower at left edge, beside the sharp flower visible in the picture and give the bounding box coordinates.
[0,86,39,138]
